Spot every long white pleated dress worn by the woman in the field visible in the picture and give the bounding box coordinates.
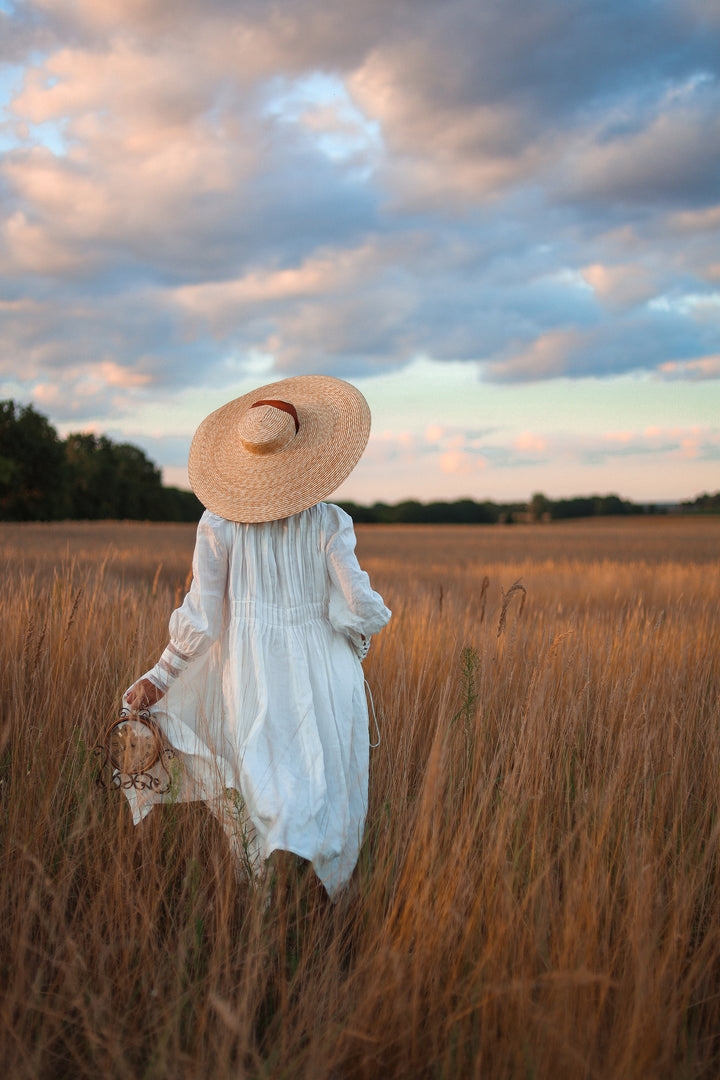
[125,502,391,896]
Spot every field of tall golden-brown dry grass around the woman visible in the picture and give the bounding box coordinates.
[0,517,720,1080]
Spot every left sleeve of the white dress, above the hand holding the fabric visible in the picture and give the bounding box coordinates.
[145,511,228,690]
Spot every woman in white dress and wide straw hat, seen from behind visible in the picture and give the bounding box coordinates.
[124,375,391,897]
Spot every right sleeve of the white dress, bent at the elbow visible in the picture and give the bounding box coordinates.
[325,503,392,647]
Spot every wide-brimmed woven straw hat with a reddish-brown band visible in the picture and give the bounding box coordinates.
[188,375,370,523]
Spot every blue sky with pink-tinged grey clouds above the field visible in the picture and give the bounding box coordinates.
[0,0,720,502]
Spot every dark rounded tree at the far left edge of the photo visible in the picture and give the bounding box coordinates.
[0,401,67,522]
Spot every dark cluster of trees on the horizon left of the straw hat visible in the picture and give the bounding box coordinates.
[0,401,203,522]
